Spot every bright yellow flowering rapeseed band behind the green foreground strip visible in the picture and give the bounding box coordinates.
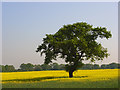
[1,69,119,83]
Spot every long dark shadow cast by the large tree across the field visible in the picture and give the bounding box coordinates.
[2,76,88,82]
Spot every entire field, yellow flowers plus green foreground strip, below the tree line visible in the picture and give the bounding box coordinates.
[1,69,118,88]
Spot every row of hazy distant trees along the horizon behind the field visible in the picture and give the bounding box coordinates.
[0,63,120,72]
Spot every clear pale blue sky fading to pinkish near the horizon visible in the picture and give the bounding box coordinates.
[2,2,118,67]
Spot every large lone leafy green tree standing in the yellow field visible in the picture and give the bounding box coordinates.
[36,22,112,77]
